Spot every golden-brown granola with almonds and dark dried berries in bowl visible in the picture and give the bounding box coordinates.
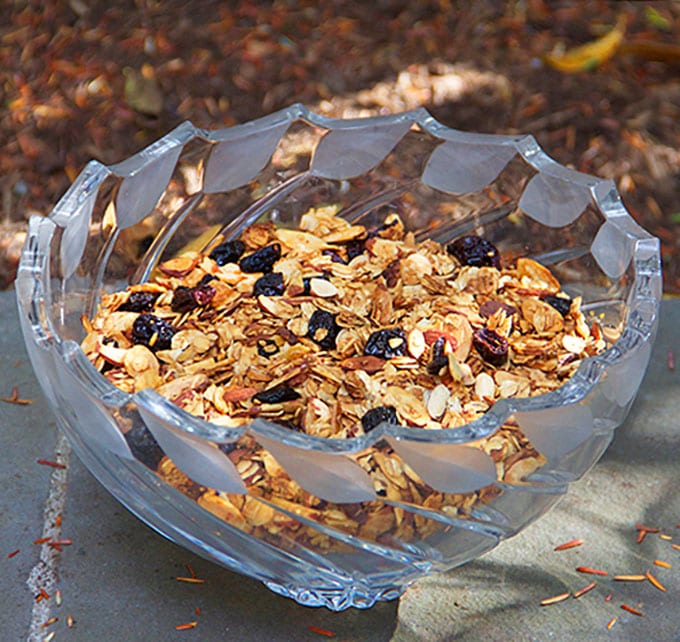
[82,206,605,549]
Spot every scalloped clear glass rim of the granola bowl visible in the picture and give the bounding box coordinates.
[17,104,661,454]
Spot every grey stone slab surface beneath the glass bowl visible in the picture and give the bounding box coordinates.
[0,292,680,642]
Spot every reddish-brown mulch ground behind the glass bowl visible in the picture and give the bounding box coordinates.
[0,0,680,294]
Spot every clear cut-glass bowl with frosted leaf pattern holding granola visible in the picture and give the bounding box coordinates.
[16,105,661,610]
